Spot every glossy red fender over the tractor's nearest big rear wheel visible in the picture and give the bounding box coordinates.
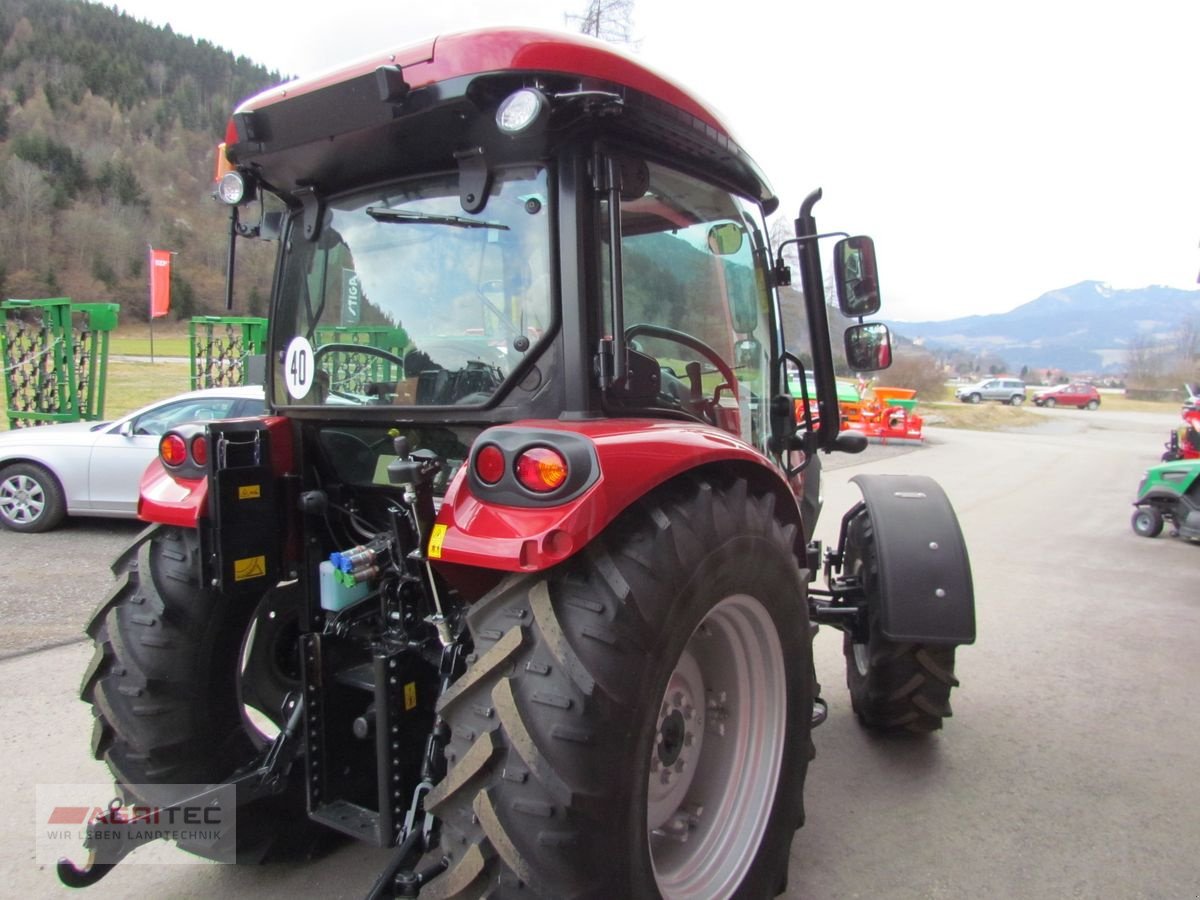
[428,419,788,572]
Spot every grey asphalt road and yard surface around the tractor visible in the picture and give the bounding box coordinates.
[0,410,1200,900]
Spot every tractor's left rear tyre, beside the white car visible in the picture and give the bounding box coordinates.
[82,526,312,862]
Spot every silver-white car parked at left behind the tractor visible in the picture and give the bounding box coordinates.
[0,385,266,532]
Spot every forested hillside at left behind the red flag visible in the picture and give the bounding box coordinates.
[0,0,282,322]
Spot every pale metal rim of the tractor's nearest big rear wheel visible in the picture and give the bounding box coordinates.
[647,595,787,900]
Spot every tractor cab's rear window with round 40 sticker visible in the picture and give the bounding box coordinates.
[275,167,552,406]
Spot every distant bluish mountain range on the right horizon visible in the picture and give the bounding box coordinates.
[888,281,1200,374]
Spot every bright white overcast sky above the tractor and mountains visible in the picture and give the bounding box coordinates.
[106,0,1200,320]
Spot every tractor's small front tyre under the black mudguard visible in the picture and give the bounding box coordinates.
[842,511,959,733]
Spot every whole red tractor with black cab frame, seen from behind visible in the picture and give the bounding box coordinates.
[59,30,974,898]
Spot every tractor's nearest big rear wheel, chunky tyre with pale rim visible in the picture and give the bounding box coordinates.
[421,480,812,900]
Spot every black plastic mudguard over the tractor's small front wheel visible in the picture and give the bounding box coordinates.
[851,475,976,644]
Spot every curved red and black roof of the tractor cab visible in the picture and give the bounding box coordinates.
[226,28,778,212]
